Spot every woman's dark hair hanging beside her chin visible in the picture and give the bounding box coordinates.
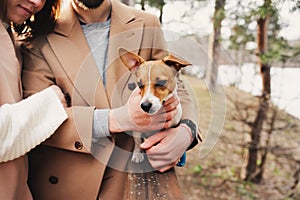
[13,0,62,40]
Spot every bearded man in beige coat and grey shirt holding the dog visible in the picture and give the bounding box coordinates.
[23,0,197,200]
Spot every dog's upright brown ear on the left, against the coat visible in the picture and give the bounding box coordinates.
[119,48,145,71]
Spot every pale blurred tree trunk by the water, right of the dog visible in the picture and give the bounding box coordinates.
[205,0,226,91]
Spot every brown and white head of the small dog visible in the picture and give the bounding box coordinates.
[119,49,191,114]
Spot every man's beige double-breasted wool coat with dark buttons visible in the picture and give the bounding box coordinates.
[22,0,197,200]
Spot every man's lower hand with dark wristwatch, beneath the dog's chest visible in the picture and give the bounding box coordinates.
[140,124,193,172]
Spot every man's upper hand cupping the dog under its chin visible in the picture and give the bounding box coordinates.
[109,88,179,132]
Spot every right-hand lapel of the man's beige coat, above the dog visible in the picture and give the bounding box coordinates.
[106,1,144,107]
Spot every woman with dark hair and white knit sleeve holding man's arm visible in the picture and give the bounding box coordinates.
[0,0,67,200]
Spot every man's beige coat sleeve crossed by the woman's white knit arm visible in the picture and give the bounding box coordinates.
[22,41,95,153]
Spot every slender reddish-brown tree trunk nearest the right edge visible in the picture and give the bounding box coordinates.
[246,0,271,183]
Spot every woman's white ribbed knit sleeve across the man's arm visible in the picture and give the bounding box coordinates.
[0,88,67,162]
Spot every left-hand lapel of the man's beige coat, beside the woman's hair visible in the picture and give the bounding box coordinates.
[48,4,109,108]
